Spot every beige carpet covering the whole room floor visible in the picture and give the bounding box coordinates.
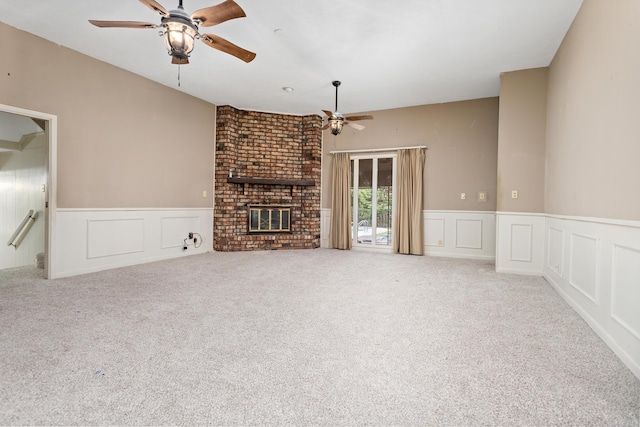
[0,249,640,426]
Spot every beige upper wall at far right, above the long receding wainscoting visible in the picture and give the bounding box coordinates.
[545,0,640,220]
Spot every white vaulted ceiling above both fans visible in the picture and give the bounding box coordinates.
[0,0,582,114]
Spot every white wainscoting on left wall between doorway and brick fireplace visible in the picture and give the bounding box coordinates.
[50,208,213,278]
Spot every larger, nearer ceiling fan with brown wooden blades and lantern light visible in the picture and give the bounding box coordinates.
[89,0,256,64]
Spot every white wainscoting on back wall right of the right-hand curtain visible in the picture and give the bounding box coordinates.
[423,210,496,260]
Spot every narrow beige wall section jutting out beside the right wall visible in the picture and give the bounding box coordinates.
[497,68,548,212]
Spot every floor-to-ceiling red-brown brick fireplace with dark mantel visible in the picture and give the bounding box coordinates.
[213,105,322,252]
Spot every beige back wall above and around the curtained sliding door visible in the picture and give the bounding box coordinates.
[322,98,498,211]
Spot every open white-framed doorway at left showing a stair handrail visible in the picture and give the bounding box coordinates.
[0,104,57,278]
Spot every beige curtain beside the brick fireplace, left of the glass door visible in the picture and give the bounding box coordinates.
[329,153,352,249]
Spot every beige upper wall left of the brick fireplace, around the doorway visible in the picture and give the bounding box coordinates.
[0,23,215,208]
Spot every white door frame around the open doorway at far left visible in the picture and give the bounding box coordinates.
[0,104,58,279]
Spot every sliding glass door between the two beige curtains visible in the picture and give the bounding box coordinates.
[351,154,396,249]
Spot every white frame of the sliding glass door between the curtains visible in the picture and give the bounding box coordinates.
[350,153,398,251]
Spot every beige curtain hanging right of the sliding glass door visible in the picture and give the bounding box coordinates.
[393,148,425,255]
